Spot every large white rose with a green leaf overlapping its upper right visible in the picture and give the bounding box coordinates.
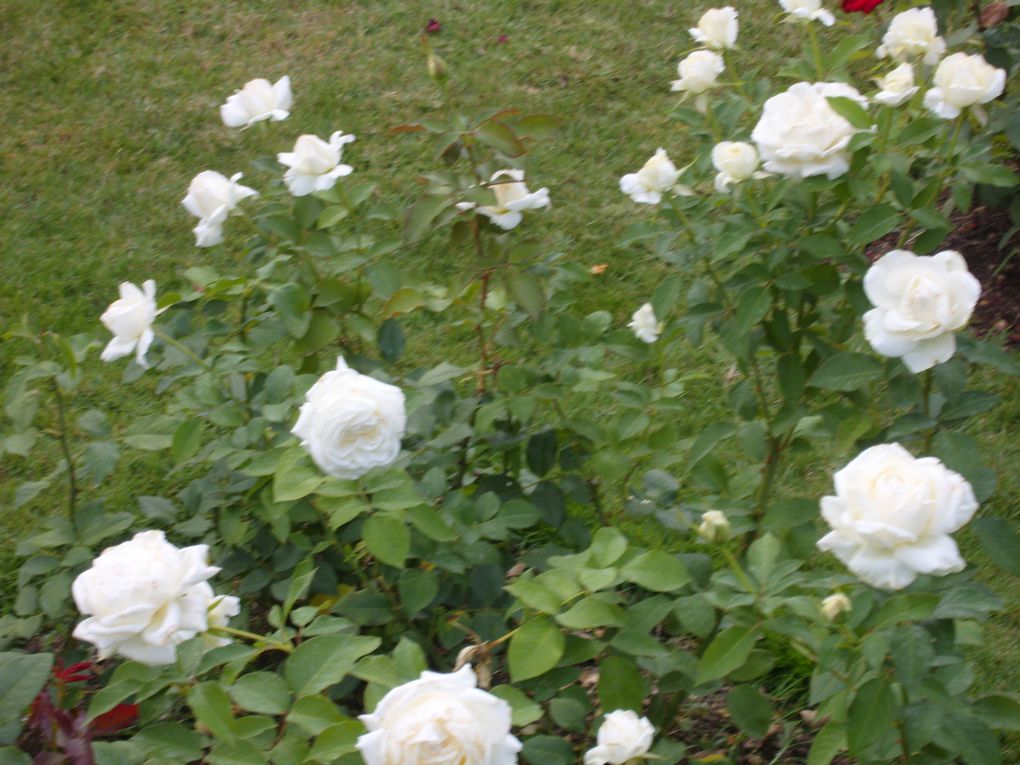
[751,83,868,180]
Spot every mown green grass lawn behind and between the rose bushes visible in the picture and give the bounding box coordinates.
[0,0,1020,754]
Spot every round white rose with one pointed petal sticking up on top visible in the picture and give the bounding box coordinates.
[291,358,407,478]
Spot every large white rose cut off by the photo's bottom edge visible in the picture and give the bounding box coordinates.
[357,666,521,765]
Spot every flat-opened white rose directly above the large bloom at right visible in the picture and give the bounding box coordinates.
[864,250,981,373]
